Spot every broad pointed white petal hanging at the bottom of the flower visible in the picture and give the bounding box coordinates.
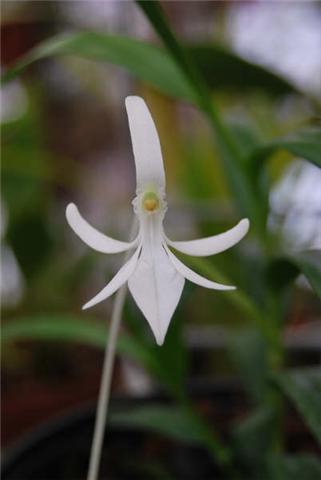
[128,242,185,345]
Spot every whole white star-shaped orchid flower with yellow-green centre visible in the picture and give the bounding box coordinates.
[66,96,249,345]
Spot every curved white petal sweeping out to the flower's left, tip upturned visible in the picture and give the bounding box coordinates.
[66,203,138,253]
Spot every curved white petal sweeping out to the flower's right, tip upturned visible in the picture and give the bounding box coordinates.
[166,218,250,257]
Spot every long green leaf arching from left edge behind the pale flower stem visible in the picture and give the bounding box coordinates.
[2,314,231,470]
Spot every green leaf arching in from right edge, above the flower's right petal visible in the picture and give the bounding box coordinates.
[249,130,321,169]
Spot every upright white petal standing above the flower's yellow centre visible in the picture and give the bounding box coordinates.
[126,96,165,191]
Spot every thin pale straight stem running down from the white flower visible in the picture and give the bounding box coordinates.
[87,220,136,480]
